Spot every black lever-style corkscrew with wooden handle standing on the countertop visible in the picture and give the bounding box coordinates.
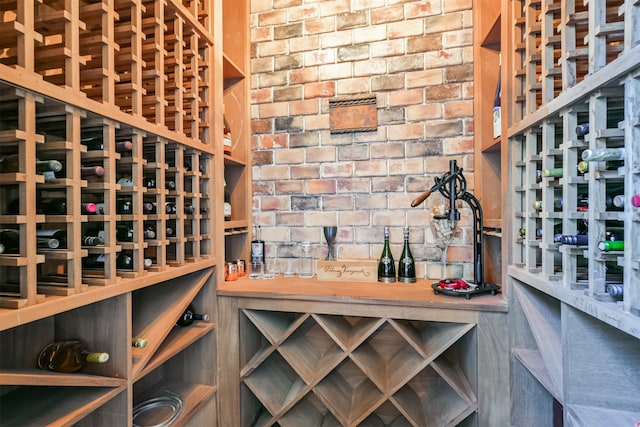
[411,160,500,299]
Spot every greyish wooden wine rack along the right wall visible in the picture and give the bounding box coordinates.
[502,0,640,426]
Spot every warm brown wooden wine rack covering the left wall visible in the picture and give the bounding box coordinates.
[0,0,251,426]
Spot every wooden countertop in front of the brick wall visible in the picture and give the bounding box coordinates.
[217,276,508,312]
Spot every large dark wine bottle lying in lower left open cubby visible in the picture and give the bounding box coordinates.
[38,340,109,373]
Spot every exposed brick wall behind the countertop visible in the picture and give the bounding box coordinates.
[251,0,473,279]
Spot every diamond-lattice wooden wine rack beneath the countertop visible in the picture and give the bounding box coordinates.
[239,309,477,426]
